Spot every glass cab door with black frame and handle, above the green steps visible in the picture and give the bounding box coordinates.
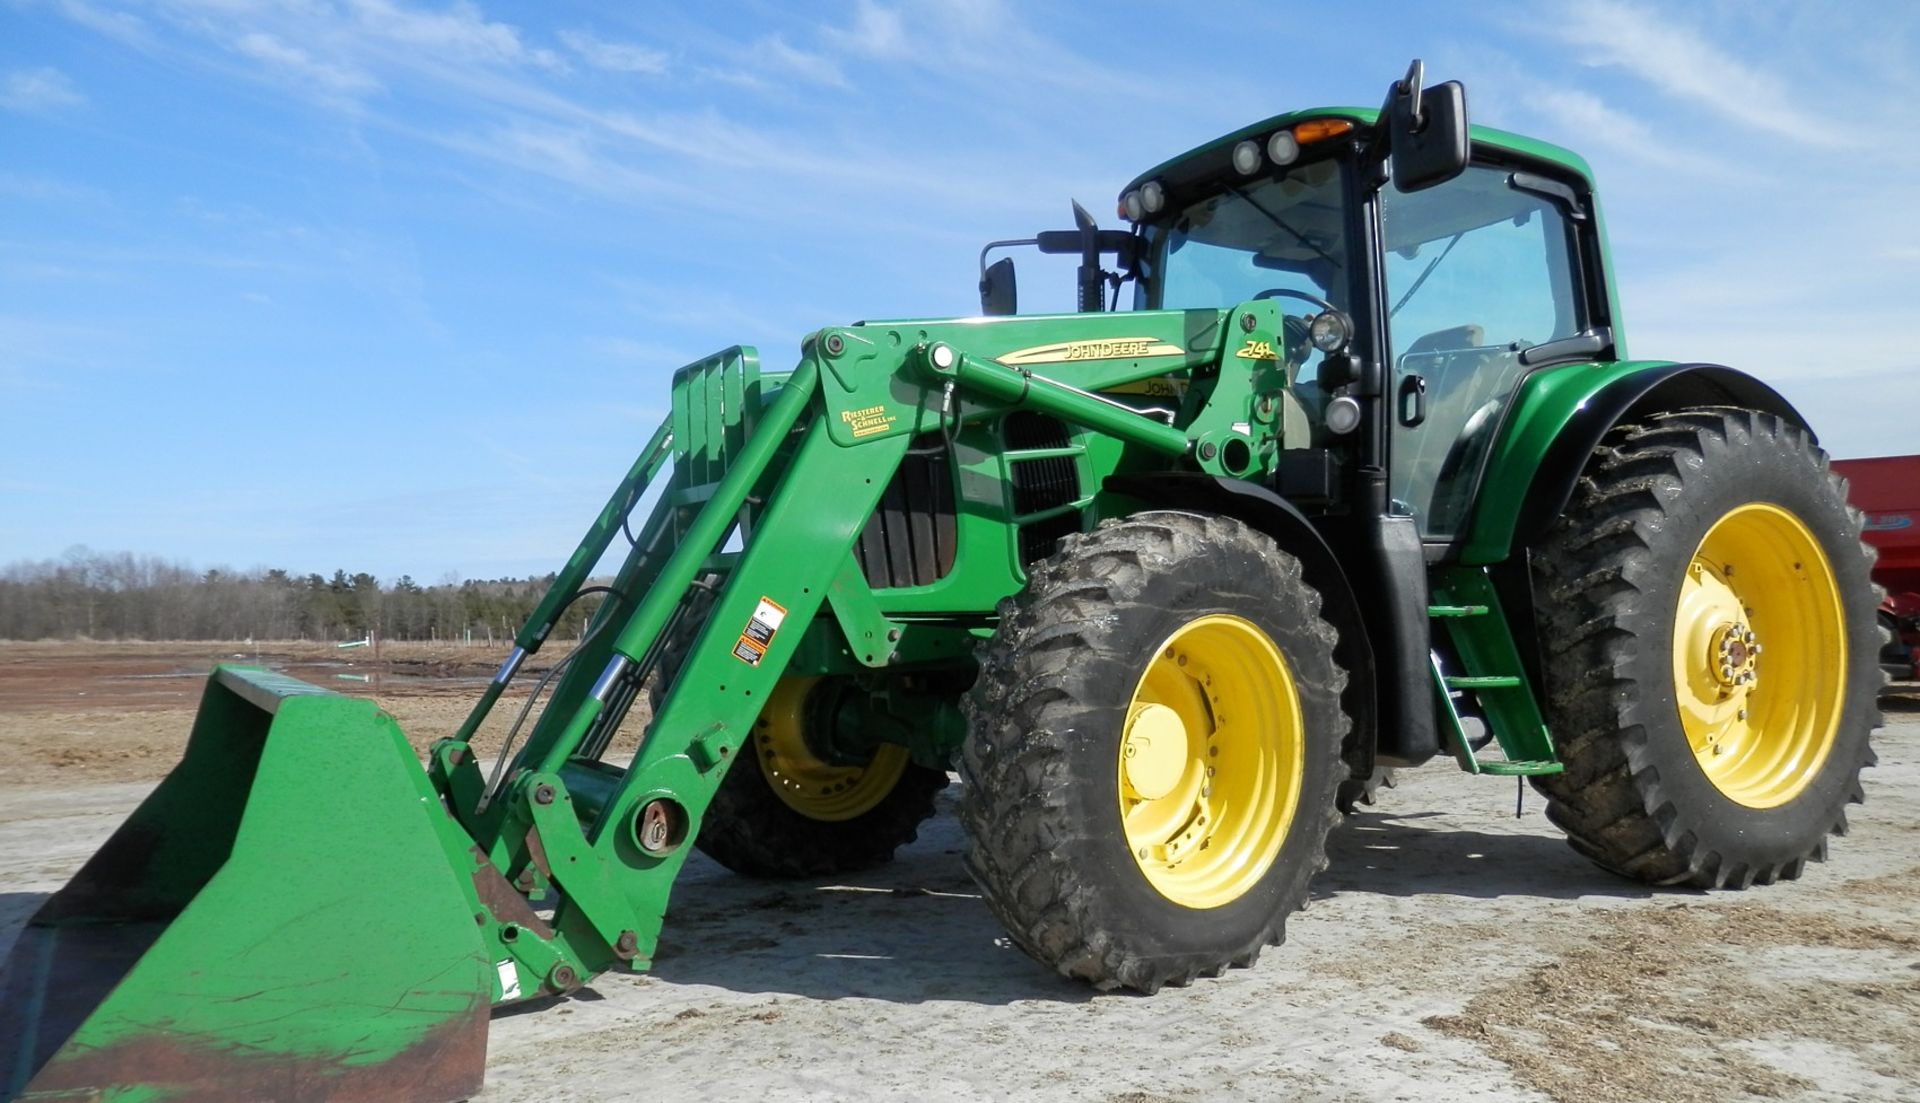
[1379,163,1592,544]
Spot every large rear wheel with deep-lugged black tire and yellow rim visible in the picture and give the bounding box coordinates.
[1534,407,1880,888]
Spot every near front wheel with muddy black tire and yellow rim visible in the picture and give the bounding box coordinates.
[960,513,1350,992]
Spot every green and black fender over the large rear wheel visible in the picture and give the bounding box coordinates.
[1459,359,1812,565]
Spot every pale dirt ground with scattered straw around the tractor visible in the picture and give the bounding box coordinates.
[0,644,1920,1103]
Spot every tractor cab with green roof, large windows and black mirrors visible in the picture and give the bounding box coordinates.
[981,63,1619,546]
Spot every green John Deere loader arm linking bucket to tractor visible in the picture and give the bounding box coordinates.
[430,302,1284,999]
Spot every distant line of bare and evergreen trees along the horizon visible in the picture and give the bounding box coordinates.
[0,548,599,642]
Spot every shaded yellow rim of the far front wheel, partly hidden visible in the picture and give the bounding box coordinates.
[753,678,908,821]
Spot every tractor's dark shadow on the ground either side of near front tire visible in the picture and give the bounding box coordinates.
[653,790,1670,1005]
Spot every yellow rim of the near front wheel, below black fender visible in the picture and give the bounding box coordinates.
[1119,615,1306,909]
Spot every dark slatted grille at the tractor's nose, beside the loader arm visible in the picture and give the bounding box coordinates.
[854,432,958,590]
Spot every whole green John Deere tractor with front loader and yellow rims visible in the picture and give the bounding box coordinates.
[0,63,1880,1099]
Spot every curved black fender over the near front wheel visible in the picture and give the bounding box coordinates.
[1104,471,1379,778]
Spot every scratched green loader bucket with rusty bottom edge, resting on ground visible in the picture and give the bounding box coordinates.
[0,667,495,1101]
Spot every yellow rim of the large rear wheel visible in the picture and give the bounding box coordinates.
[1672,502,1847,809]
